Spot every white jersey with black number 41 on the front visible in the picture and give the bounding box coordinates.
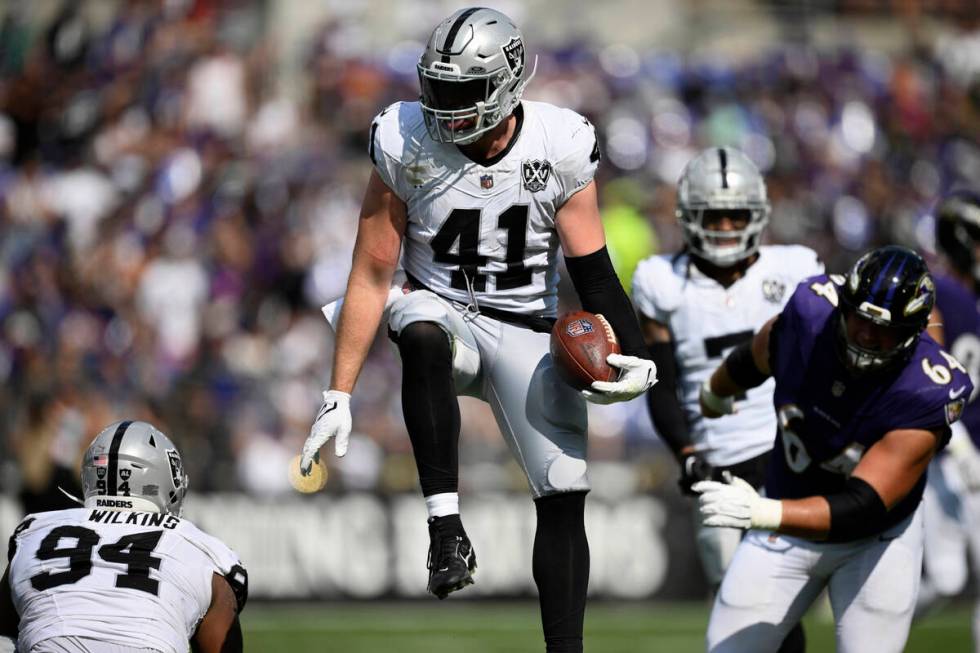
[369,100,599,317]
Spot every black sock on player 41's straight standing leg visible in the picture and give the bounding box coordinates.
[532,492,589,653]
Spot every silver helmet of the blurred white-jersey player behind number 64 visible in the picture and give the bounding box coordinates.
[677,147,770,267]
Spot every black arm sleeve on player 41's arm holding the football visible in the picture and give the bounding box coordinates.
[565,247,647,358]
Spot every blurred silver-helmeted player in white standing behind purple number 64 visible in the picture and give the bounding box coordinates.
[633,147,823,651]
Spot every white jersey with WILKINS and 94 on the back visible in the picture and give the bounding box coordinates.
[9,508,247,653]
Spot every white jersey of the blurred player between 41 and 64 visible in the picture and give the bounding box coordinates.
[633,245,823,466]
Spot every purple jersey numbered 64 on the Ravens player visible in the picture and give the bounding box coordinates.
[766,275,973,532]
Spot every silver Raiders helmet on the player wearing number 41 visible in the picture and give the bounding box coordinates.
[418,7,537,145]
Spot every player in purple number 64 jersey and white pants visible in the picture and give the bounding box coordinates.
[693,246,973,653]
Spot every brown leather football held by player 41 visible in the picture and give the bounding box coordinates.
[551,311,619,390]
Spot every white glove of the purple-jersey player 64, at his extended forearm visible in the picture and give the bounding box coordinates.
[691,476,783,531]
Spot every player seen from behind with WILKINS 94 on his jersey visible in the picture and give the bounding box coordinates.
[0,421,248,653]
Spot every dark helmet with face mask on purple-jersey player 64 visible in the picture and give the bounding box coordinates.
[837,246,936,375]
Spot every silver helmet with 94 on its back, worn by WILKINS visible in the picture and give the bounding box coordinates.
[82,421,187,517]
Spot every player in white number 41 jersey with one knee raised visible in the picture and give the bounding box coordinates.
[301,8,655,651]
